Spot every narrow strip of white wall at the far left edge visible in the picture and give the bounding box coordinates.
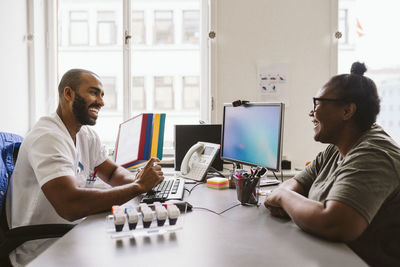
[0,0,29,135]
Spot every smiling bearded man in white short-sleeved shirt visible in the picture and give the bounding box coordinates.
[7,69,164,266]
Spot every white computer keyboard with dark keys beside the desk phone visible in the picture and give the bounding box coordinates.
[141,177,185,203]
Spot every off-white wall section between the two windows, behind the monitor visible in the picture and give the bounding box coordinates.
[211,0,337,170]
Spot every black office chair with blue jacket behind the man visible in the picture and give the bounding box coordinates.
[0,132,74,266]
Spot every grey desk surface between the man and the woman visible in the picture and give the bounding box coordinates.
[28,184,366,267]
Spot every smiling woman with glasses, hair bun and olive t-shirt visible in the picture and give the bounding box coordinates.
[264,62,400,266]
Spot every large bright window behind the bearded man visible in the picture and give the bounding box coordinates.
[55,0,206,151]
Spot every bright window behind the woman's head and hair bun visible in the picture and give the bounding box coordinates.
[338,0,400,143]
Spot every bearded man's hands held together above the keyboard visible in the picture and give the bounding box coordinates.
[135,158,164,193]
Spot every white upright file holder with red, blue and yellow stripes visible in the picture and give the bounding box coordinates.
[115,113,166,169]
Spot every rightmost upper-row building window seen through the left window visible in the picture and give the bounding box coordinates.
[182,10,200,44]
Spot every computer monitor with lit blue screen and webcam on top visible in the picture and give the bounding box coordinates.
[221,103,284,171]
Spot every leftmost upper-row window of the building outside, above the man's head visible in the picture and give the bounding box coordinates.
[69,11,89,45]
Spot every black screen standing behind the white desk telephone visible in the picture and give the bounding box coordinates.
[174,124,223,171]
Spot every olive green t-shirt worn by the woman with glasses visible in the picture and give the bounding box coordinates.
[294,125,400,266]
